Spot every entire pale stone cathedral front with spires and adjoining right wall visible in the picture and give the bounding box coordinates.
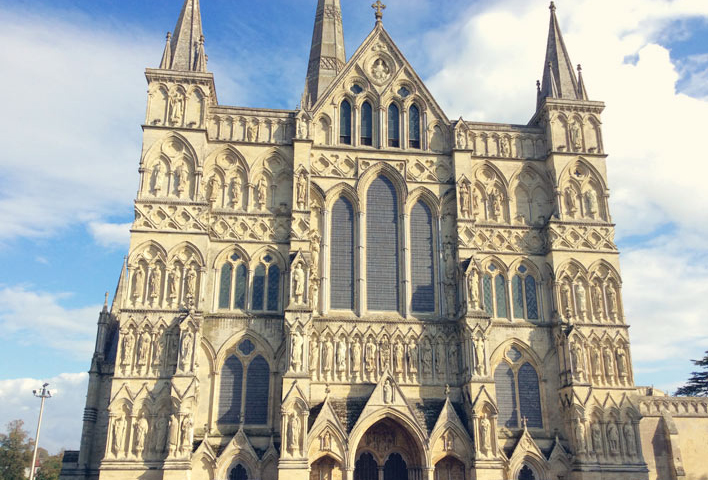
[62,0,708,480]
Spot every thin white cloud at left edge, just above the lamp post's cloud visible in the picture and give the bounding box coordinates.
[0,285,101,360]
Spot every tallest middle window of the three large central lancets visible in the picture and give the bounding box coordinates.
[366,176,399,311]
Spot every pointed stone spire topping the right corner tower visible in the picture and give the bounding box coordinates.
[539,2,585,100]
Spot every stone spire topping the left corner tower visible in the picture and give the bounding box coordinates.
[160,0,206,72]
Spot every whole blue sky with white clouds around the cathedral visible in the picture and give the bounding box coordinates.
[0,0,708,449]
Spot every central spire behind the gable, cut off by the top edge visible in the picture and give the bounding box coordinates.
[303,0,347,107]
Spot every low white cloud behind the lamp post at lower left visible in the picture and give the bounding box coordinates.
[0,373,88,454]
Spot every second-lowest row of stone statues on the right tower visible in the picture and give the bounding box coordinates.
[570,340,631,386]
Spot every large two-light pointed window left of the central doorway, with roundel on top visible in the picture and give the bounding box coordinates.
[217,339,270,425]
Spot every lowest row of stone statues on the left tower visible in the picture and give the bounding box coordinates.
[107,414,194,459]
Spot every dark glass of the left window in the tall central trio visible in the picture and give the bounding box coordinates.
[330,197,354,310]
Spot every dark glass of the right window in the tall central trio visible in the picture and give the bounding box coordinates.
[411,202,435,312]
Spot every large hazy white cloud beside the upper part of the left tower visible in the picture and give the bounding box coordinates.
[0,9,153,244]
